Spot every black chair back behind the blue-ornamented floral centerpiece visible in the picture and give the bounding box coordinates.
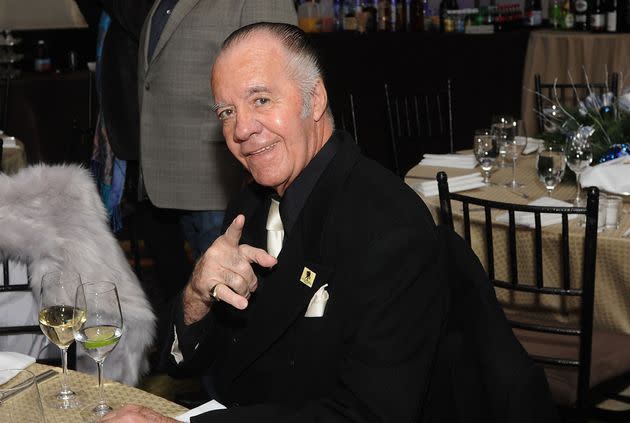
[534,72,619,133]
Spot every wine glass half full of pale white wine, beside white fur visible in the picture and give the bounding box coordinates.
[39,270,85,409]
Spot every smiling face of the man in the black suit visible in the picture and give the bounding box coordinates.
[212,34,318,195]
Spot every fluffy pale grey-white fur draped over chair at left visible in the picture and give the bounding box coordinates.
[0,165,155,385]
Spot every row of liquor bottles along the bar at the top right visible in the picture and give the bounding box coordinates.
[298,0,630,34]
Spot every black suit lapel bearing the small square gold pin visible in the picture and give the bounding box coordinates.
[228,132,358,378]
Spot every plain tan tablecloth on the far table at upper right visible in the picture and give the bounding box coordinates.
[521,30,630,134]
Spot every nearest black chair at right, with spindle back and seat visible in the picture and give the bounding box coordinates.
[437,172,630,419]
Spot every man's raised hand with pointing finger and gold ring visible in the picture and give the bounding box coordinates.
[184,214,277,325]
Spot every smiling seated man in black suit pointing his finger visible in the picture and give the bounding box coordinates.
[104,23,448,423]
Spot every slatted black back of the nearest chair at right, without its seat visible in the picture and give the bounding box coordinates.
[437,172,599,408]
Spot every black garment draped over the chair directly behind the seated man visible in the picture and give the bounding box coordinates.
[424,226,559,423]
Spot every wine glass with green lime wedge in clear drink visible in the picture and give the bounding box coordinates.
[74,282,123,422]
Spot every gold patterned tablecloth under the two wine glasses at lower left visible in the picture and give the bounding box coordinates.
[23,362,187,423]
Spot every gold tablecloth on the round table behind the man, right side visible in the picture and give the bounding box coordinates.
[406,154,630,334]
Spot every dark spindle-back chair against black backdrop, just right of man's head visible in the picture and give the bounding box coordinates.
[385,79,454,177]
